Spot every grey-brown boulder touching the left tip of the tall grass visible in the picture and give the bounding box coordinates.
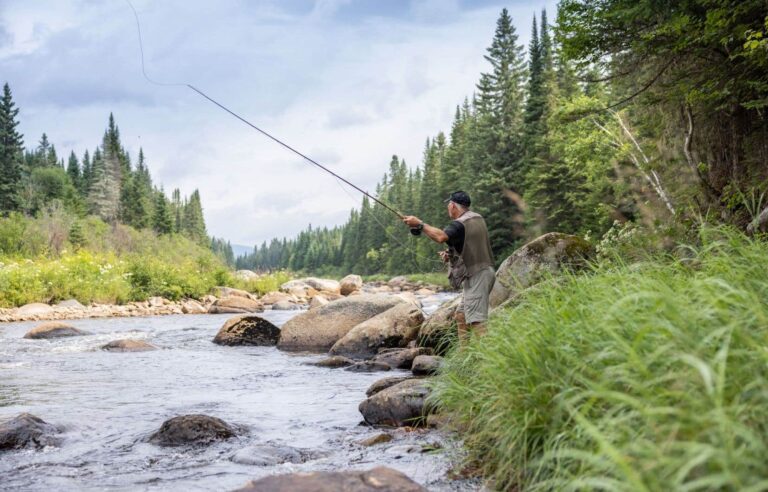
[358,379,430,427]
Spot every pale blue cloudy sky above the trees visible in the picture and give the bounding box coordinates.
[0,0,556,245]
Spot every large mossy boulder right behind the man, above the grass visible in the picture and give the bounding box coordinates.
[491,232,592,307]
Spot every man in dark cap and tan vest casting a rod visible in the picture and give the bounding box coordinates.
[403,191,496,342]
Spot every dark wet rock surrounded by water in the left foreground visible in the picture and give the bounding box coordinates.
[148,415,235,446]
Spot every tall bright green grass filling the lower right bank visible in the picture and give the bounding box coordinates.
[435,229,768,491]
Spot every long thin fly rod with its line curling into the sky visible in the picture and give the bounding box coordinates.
[125,0,443,265]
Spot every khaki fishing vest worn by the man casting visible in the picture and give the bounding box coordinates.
[448,210,493,289]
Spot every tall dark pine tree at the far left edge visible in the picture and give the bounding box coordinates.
[0,83,24,212]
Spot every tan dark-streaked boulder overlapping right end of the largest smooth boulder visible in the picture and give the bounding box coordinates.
[330,302,424,359]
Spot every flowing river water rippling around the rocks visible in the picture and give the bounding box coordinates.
[0,295,474,490]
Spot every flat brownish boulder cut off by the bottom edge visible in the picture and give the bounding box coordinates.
[238,466,427,492]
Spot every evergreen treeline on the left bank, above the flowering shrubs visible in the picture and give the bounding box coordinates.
[0,83,222,252]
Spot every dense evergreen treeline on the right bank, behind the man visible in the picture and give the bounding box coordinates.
[237,0,768,273]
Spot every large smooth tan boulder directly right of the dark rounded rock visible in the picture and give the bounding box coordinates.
[277,294,403,352]
